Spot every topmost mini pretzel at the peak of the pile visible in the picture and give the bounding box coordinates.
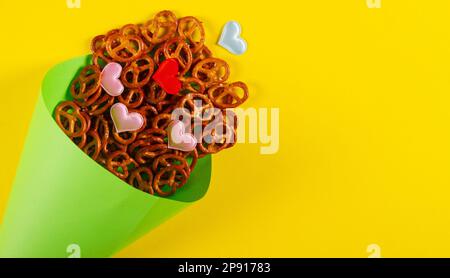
[141,11,177,45]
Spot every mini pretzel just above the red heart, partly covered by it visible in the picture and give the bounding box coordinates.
[164,38,192,76]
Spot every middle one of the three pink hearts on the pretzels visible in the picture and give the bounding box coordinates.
[110,103,144,133]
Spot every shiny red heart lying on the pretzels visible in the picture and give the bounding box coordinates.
[153,59,181,95]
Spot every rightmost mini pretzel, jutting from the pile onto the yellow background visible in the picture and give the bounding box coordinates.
[208,82,248,109]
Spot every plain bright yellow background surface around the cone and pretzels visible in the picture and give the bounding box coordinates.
[0,0,450,257]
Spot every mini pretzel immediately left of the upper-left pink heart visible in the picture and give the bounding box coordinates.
[70,65,100,100]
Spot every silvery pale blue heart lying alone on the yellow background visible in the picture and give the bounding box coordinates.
[219,21,247,55]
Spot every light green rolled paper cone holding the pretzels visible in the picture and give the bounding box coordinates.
[0,56,211,258]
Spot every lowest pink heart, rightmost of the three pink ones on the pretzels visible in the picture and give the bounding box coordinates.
[167,121,197,152]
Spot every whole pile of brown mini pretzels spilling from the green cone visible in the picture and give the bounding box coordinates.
[55,11,248,196]
